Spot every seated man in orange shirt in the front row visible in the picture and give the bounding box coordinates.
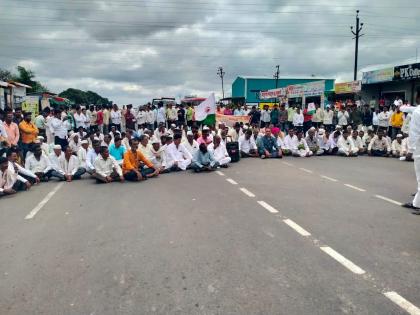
[122,138,159,181]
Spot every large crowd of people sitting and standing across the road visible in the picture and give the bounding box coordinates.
[0,97,412,199]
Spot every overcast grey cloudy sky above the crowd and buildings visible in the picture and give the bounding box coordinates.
[0,0,420,104]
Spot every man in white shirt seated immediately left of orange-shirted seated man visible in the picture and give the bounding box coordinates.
[92,146,124,184]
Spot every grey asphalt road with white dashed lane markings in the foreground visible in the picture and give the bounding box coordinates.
[0,157,420,315]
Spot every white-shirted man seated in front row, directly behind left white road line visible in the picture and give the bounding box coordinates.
[25,145,64,182]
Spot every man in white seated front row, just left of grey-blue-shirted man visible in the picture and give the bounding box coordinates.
[165,134,192,171]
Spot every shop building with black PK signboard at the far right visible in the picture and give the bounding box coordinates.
[361,63,420,105]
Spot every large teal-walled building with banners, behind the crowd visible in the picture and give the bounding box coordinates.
[232,76,335,105]
